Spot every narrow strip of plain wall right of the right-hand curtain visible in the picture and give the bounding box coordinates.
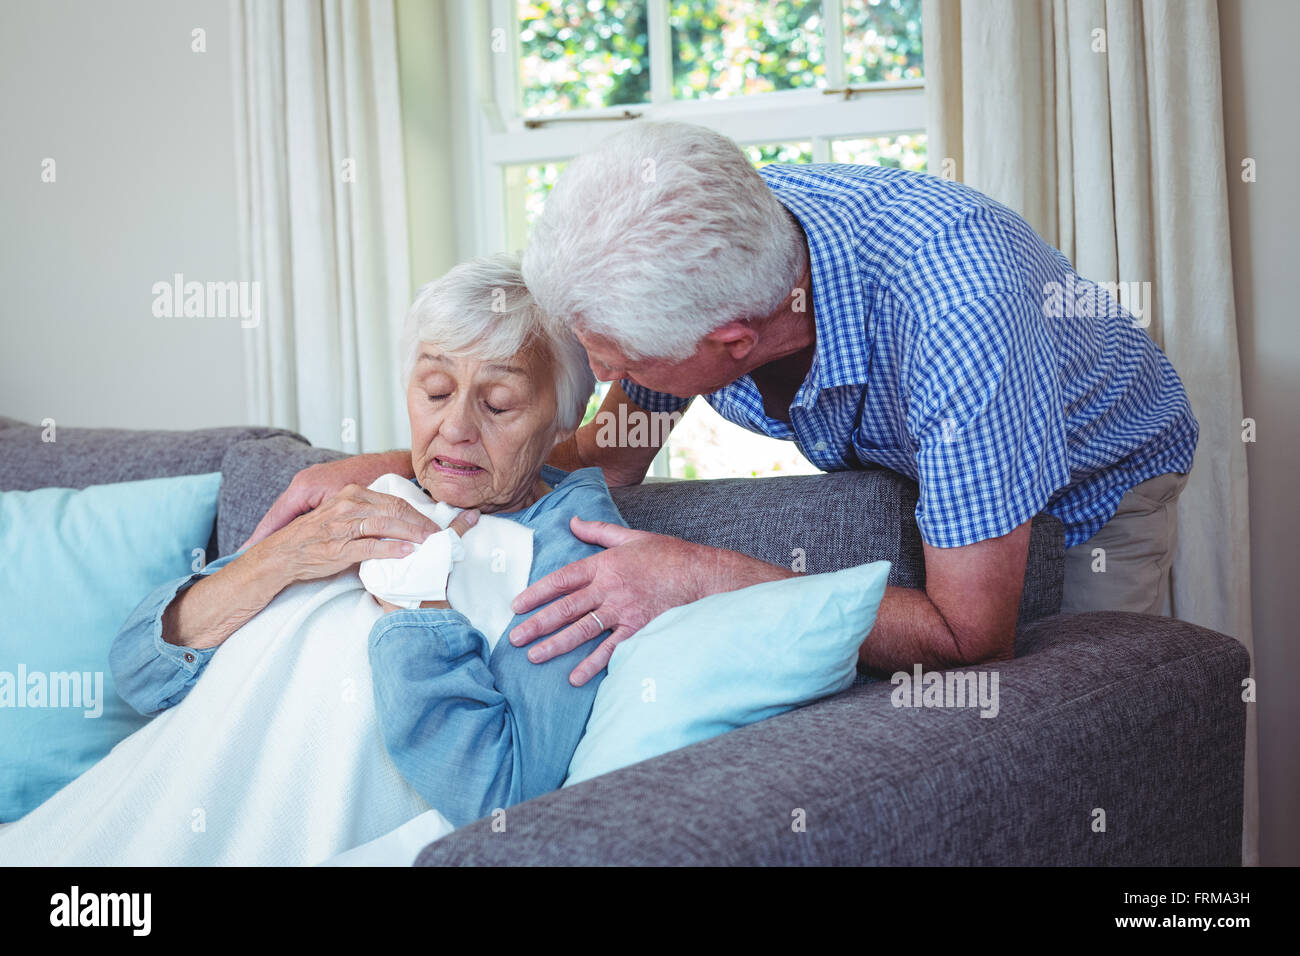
[1218,0,1300,866]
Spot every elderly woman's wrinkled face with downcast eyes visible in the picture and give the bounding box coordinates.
[407,346,568,514]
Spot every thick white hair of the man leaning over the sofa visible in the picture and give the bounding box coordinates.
[523,122,806,359]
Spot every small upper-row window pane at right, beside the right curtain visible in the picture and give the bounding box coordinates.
[844,0,924,85]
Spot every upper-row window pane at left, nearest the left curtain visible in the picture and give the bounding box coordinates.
[516,0,650,116]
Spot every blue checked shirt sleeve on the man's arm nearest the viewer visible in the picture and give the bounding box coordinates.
[905,289,1070,548]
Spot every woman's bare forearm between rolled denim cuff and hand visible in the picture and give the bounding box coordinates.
[163,544,293,648]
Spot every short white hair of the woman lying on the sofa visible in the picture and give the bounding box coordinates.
[400,252,595,431]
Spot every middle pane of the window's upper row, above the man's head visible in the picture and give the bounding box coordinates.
[668,0,826,100]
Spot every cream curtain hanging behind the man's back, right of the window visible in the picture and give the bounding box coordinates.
[923,0,1258,865]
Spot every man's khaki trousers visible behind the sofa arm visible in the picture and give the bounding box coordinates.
[1061,472,1187,614]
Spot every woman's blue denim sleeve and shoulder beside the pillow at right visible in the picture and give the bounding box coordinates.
[369,468,627,826]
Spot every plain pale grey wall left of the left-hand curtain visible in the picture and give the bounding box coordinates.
[0,0,246,428]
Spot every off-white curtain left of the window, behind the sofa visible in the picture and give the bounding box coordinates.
[233,0,411,451]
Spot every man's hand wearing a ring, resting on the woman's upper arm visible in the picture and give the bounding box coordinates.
[510,518,793,687]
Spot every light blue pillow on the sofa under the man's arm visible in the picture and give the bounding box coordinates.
[564,561,889,787]
